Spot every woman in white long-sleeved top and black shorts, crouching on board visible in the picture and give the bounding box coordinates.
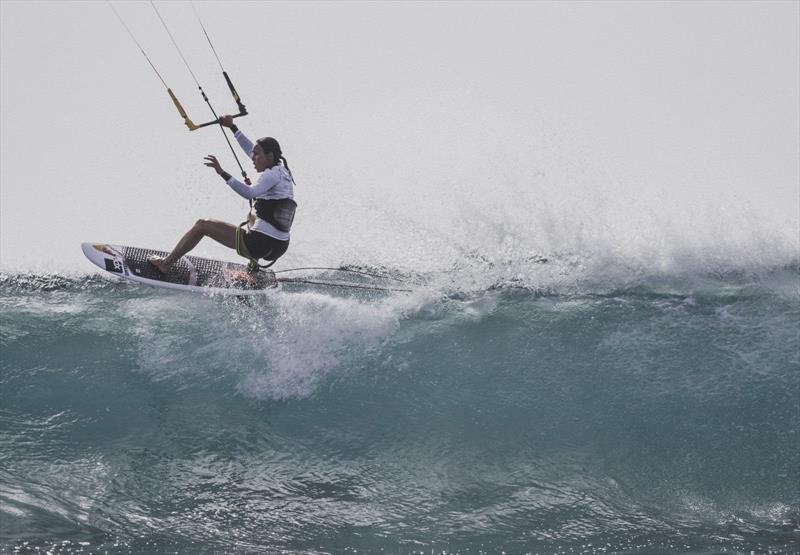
[148,116,297,273]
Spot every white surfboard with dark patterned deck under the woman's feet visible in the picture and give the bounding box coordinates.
[81,243,278,295]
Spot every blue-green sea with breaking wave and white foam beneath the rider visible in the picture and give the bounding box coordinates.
[0,257,800,553]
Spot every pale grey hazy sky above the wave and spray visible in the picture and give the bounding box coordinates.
[0,0,800,271]
